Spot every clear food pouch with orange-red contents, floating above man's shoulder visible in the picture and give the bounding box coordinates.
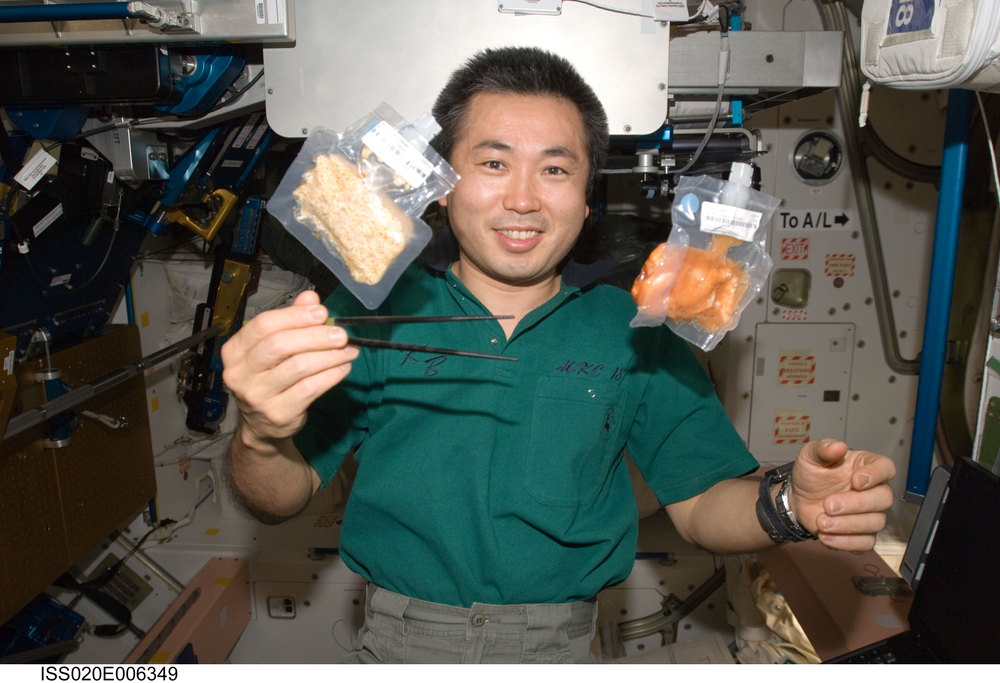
[630,164,780,351]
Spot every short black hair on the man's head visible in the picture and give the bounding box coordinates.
[432,47,608,193]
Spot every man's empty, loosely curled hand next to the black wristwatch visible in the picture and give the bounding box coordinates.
[789,439,896,550]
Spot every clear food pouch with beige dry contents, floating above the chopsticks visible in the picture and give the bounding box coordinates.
[267,104,459,309]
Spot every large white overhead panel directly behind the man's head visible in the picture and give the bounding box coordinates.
[264,0,672,137]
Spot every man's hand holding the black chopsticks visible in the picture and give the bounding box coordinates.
[222,291,358,447]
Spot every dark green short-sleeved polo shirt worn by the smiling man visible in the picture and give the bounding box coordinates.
[295,265,757,607]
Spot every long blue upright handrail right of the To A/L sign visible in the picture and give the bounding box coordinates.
[904,89,972,503]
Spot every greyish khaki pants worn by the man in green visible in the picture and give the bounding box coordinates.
[343,584,597,664]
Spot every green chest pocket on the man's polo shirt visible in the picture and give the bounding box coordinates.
[524,377,628,507]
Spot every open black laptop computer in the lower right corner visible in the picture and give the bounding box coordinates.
[827,458,1000,664]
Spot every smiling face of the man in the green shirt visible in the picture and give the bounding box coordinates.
[440,93,590,285]
